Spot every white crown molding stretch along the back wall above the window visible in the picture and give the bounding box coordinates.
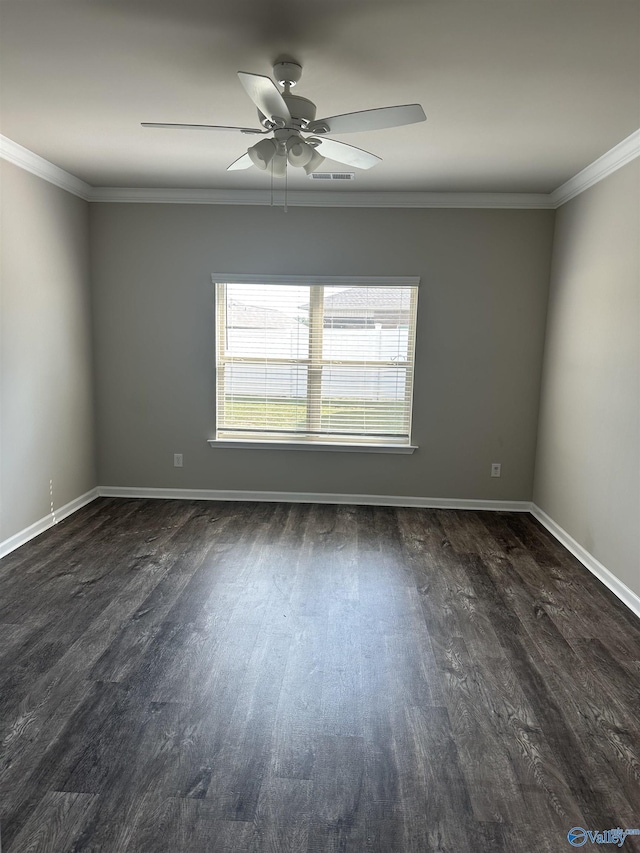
[89,187,553,209]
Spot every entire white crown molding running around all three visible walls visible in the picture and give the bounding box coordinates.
[0,130,640,210]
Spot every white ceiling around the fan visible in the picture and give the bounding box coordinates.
[0,0,640,193]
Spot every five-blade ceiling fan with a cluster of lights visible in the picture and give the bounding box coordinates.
[142,61,426,177]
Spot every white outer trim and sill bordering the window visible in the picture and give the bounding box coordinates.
[207,273,420,454]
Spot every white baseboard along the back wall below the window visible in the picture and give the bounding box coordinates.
[98,486,531,512]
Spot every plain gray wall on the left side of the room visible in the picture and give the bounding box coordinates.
[0,160,96,542]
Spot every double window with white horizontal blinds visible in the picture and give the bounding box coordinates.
[213,275,418,449]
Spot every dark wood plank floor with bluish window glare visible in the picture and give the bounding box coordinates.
[0,499,640,853]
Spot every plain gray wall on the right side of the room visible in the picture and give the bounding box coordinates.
[534,160,640,594]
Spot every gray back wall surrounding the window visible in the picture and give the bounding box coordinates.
[90,204,554,500]
